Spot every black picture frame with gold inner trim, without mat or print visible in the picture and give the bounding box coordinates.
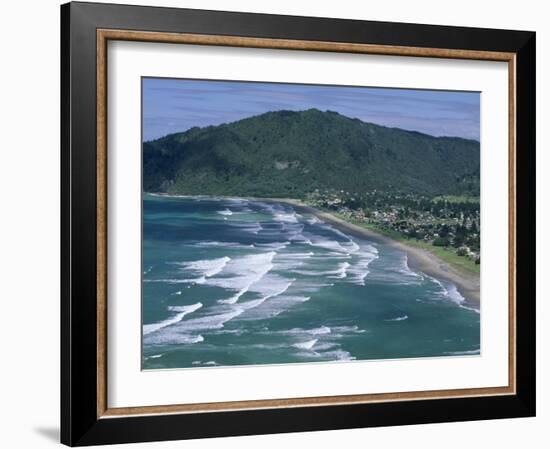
[61,2,535,446]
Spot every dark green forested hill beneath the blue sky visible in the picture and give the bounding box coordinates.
[143,109,479,198]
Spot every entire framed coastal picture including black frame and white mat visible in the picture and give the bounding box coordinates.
[61,3,535,446]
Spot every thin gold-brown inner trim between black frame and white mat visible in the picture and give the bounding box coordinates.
[96,29,516,418]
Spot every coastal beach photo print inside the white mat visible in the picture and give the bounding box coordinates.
[141,77,483,370]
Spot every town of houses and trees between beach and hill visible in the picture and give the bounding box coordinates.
[306,190,480,264]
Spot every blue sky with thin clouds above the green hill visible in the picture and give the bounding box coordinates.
[142,78,480,141]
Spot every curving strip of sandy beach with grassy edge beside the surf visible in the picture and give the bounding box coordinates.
[257,198,480,310]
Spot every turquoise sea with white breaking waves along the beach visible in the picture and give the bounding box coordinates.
[142,195,480,369]
